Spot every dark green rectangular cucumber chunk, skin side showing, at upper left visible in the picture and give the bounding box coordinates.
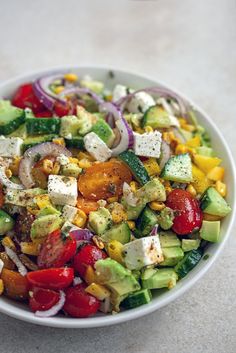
[26,118,61,135]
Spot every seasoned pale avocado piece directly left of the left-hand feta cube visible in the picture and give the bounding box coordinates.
[5,188,47,207]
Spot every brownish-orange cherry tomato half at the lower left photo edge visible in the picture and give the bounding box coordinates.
[1,268,29,300]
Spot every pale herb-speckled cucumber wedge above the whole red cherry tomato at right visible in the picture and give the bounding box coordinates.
[160,153,192,183]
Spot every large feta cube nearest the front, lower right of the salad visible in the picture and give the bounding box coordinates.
[123,235,163,270]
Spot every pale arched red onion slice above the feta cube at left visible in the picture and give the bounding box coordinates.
[19,142,71,189]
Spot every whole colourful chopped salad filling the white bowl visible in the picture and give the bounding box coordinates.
[0,73,231,318]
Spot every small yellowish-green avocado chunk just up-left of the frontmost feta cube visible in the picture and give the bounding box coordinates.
[101,222,131,244]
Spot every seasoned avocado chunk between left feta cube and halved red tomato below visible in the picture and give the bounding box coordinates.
[30,214,62,243]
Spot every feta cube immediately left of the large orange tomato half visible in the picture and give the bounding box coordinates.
[48,175,78,206]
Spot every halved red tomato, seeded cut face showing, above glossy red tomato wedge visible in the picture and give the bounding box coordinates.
[37,229,76,268]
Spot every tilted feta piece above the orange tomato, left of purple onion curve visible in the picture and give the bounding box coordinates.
[84,132,112,162]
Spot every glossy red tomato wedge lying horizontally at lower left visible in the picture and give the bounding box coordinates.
[27,267,74,290]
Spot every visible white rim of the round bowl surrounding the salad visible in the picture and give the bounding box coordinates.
[0,67,236,328]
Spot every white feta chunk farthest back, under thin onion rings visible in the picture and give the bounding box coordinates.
[126,92,156,113]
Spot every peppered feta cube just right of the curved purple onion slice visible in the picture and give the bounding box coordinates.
[133,131,161,158]
